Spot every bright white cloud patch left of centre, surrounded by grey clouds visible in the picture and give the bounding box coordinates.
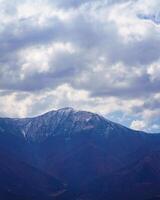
[19,42,75,79]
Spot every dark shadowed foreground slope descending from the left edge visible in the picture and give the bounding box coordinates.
[0,152,71,200]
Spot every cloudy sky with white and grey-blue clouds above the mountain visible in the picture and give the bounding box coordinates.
[0,0,160,133]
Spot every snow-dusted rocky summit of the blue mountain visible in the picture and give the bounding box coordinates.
[0,107,133,141]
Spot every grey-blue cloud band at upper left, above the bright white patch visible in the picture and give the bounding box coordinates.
[0,18,64,58]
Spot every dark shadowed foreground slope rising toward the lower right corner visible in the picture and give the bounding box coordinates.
[82,152,160,200]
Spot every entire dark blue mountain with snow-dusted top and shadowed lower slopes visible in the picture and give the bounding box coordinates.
[0,108,160,200]
